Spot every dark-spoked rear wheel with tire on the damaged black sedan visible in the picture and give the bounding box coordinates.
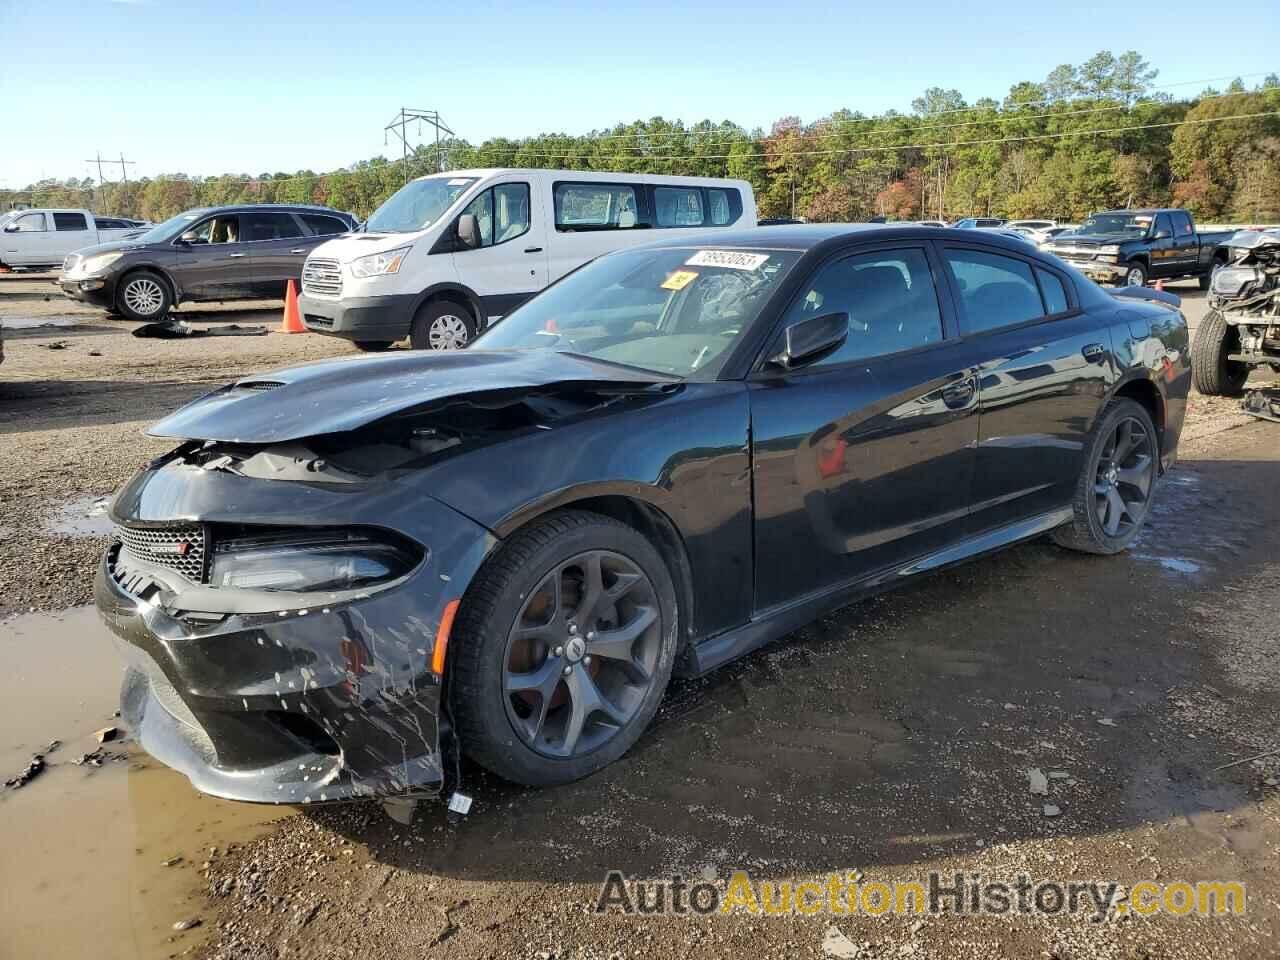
[1053,398,1160,554]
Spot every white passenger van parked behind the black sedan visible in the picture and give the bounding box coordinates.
[298,169,755,351]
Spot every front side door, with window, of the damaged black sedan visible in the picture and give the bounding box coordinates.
[749,243,978,613]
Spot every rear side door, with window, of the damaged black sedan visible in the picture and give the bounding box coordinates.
[942,243,1115,531]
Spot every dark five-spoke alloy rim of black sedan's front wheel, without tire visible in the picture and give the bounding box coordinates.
[502,550,662,759]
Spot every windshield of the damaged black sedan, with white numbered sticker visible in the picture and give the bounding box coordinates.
[474,247,800,376]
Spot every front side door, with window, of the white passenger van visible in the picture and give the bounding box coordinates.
[452,179,547,326]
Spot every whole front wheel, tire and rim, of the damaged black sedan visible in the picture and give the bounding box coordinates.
[448,511,677,786]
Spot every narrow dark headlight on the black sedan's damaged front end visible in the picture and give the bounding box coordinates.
[209,530,422,593]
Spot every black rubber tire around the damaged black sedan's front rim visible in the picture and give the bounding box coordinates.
[447,509,678,787]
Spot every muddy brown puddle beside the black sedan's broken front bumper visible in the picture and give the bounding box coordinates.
[0,607,292,960]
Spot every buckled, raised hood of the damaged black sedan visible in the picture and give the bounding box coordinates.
[147,349,676,443]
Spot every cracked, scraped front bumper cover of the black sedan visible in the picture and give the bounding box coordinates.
[95,467,493,804]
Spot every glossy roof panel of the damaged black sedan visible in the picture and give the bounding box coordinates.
[629,223,1030,253]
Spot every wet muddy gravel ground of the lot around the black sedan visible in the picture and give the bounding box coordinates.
[0,273,1280,960]
